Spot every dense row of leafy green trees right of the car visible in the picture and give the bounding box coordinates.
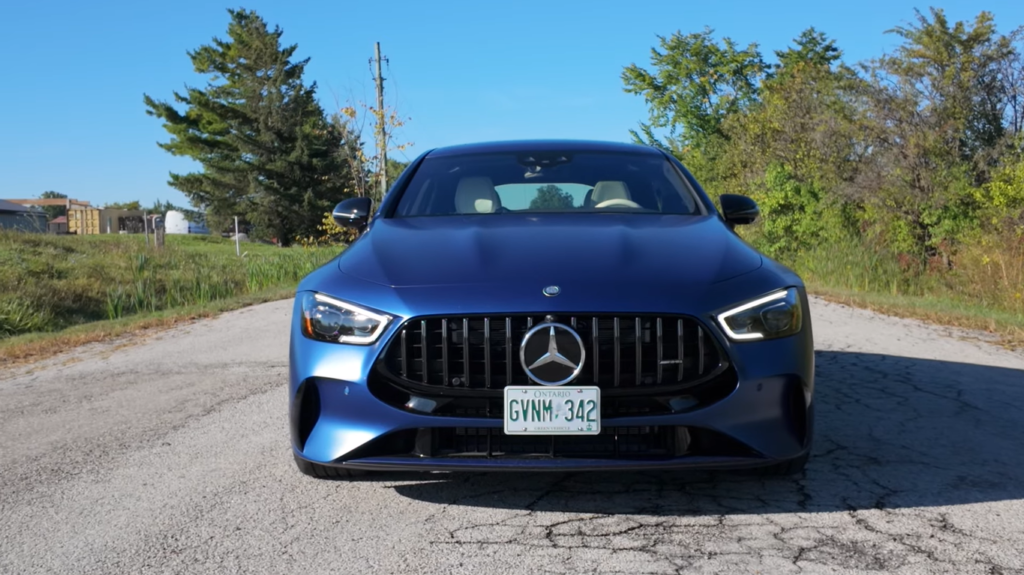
[622,8,1024,276]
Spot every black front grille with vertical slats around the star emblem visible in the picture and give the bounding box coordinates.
[383,314,725,395]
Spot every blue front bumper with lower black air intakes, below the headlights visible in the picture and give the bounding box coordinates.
[289,302,814,471]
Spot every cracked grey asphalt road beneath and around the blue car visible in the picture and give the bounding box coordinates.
[0,300,1024,575]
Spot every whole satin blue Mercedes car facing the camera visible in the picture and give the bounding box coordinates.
[289,140,814,478]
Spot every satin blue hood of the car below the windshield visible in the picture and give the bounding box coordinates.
[338,214,762,288]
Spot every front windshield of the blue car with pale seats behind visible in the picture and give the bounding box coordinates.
[394,151,700,217]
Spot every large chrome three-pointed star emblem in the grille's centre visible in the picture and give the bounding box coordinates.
[519,322,587,386]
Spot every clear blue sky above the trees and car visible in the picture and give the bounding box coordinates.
[0,0,1024,204]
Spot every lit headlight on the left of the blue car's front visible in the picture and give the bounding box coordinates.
[301,292,391,345]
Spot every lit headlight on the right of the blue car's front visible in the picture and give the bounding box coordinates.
[718,288,804,342]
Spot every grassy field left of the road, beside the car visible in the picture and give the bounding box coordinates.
[0,231,339,341]
